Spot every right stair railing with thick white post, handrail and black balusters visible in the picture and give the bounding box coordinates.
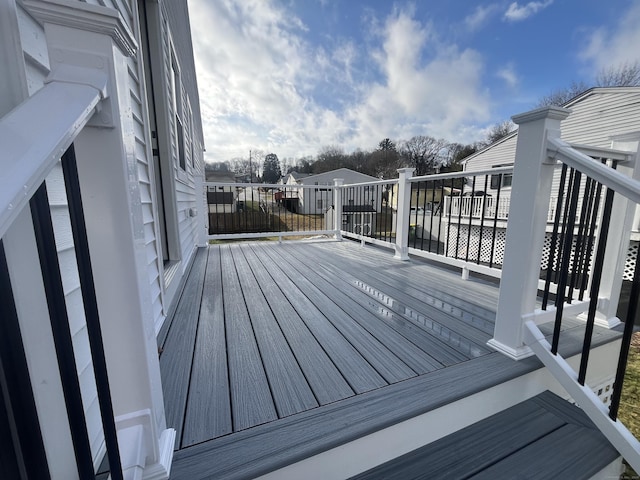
[489,107,640,471]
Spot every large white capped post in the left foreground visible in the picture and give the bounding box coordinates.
[25,0,175,479]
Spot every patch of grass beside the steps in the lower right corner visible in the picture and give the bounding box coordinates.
[618,332,640,480]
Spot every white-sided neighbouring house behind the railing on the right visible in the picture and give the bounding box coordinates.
[458,87,640,268]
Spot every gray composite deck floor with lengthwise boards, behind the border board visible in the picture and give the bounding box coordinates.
[160,242,497,448]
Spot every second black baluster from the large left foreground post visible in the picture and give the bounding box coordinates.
[30,183,94,479]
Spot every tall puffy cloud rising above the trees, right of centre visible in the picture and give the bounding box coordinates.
[350,10,490,145]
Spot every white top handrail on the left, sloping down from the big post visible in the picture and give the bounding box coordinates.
[0,82,102,237]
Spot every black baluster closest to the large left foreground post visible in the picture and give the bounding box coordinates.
[62,144,123,480]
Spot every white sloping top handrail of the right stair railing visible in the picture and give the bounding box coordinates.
[547,138,640,203]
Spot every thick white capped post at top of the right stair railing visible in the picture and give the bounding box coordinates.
[488,107,570,359]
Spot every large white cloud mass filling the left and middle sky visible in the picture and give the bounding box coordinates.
[189,0,490,161]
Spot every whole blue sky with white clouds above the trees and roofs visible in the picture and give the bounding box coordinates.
[189,0,640,162]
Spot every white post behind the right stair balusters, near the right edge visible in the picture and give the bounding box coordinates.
[594,132,640,328]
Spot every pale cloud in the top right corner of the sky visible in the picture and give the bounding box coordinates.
[580,0,640,70]
